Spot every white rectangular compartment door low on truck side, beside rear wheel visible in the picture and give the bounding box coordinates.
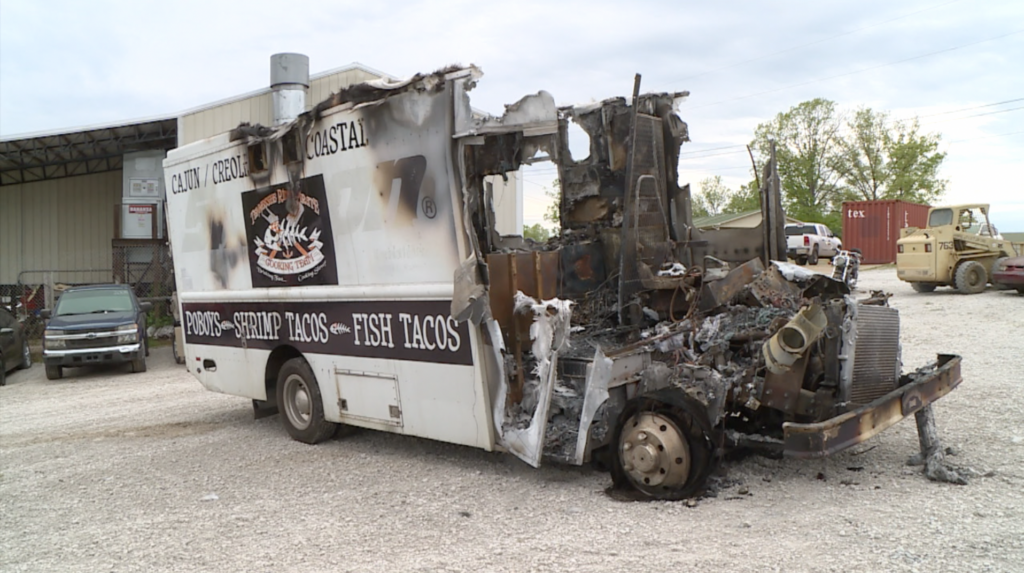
[333,369,402,428]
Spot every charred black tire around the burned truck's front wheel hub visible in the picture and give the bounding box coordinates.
[609,391,715,500]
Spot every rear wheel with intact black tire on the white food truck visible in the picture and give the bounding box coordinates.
[276,358,338,444]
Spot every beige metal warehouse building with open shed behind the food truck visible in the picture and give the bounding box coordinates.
[0,54,522,311]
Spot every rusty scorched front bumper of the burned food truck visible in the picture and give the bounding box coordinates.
[782,354,963,458]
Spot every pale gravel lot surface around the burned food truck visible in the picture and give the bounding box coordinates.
[0,268,1024,572]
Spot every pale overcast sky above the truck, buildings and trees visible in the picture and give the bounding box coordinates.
[0,0,1024,231]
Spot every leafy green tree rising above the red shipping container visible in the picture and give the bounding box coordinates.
[838,107,946,204]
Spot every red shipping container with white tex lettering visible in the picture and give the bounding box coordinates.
[843,201,930,265]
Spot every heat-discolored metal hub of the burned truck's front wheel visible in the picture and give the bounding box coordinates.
[618,411,690,490]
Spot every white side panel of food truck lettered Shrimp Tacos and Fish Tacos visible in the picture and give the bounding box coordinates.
[164,77,497,450]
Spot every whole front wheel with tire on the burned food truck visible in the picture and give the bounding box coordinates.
[611,397,714,500]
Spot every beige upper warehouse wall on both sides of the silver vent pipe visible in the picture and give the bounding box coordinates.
[178,70,377,146]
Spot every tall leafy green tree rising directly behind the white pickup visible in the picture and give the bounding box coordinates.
[751,98,843,221]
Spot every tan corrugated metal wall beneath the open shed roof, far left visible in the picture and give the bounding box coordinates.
[0,171,121,284]
